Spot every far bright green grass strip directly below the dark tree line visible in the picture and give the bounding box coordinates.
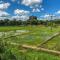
[0,26,60,32]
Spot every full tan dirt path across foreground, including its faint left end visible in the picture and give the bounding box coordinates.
[8,42,60,55]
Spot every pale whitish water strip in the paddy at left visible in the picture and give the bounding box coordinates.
[0,30,29,38]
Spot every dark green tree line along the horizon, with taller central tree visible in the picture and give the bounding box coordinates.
[0,16,60,26]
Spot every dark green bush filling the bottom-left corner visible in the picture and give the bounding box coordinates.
[0,40,16,60]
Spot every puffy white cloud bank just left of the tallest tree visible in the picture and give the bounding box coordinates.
[12,9,30,20]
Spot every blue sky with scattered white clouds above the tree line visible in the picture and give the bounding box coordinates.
[0,0,60,20]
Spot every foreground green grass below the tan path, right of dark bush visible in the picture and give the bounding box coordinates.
[7,46,60,60]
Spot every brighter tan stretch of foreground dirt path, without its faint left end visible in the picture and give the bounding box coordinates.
[22,45,60,55]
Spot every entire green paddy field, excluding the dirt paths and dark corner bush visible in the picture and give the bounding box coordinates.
[0,26,60,60]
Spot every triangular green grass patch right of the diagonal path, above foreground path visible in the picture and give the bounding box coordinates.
[43,35,60,51]
